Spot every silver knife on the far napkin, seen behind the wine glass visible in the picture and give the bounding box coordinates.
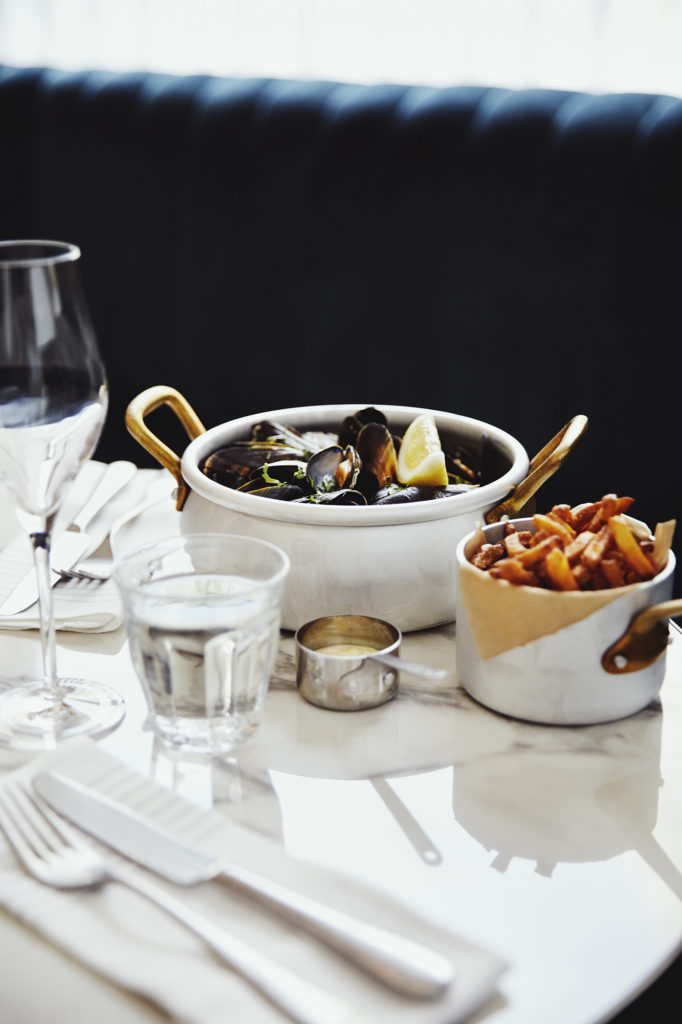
[0,460,137,616]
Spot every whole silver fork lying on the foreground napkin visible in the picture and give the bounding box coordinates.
[0,781,363,1024]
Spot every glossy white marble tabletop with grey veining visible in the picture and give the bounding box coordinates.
[0,491,682,1024]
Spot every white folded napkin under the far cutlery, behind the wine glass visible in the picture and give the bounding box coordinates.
[0,460,173,633]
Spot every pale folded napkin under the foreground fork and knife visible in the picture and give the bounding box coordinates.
[0,738,504,1024]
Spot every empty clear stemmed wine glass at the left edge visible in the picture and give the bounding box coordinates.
[0,241,124,751]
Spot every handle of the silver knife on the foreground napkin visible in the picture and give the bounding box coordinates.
[221,864,455,999]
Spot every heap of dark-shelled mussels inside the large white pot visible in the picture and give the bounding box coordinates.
[201,407,480,505]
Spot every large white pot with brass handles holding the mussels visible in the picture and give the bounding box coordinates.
[126,387,577,632]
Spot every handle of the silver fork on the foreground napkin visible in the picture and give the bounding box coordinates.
[111,862,370,1024]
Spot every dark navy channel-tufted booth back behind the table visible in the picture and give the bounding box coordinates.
[0,68,682,585]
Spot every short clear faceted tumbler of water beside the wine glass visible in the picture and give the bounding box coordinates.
[114,534,289,756]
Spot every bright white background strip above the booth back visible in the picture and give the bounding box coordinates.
[0,0,682,95]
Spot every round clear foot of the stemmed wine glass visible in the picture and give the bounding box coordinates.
[0,678,126,751]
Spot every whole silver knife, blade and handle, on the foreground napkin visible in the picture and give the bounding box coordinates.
[33,771,455,998]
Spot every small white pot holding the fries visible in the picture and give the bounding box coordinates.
[456,519,675,725]
